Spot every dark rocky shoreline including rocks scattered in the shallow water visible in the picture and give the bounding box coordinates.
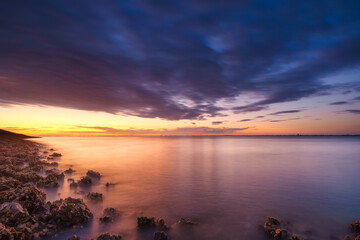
[0,137,360,240]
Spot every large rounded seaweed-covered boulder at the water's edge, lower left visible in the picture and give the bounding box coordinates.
[44,197,92,228]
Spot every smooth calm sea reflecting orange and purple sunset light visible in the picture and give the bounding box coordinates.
[36,137,360,240]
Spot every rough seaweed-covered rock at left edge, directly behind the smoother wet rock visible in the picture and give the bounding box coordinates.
[0,184,46,213]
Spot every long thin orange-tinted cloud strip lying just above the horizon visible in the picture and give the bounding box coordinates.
[73,126,249,136]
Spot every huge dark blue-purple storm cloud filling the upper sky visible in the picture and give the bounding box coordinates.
[0,0,360,120]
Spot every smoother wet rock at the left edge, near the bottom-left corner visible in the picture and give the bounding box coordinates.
[0,202,35,227]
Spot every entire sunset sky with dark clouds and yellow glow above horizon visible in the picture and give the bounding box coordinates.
[0,0,360,136]
